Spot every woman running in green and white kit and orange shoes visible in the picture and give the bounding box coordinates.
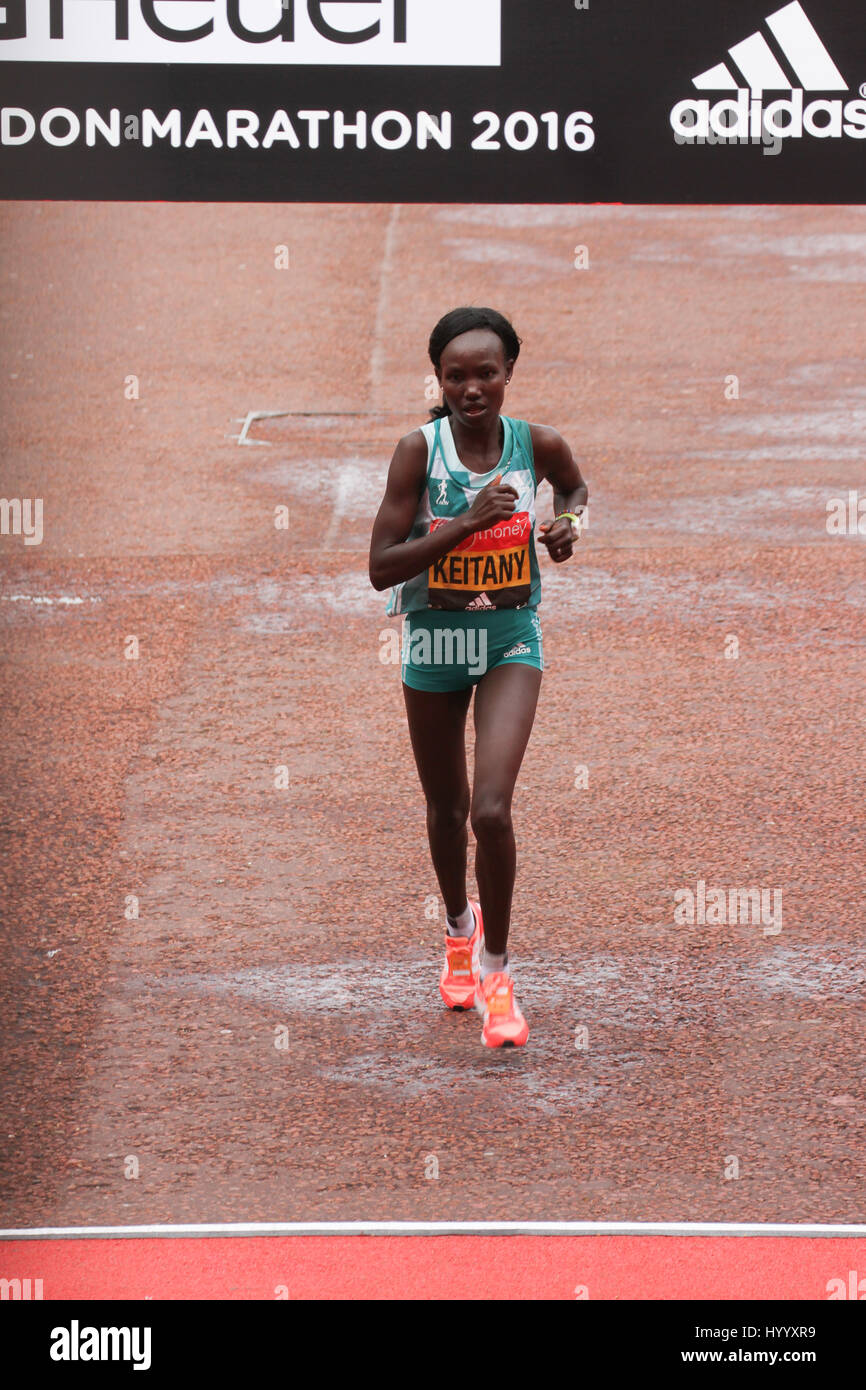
[370,307,588,1047]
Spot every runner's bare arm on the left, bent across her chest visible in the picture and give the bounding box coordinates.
[370,430,517,591]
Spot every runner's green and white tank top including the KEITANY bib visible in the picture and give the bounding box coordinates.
[385,405,541,616]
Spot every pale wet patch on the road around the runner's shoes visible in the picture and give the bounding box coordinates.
[126,942,866,1116]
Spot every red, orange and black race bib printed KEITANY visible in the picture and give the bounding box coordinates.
[427,512,532,612]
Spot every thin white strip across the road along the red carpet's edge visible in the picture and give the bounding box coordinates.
[0,1220,866,1240]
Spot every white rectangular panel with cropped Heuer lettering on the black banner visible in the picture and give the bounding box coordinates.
[0,0,502,67]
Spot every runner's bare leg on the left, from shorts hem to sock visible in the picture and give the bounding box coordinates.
[403,682,473,917]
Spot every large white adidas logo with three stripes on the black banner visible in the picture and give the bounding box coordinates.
[670,0,866,140]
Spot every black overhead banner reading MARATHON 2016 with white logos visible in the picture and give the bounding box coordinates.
[0,0,866,203]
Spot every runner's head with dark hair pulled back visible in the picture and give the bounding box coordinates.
[430,307,520,427]
